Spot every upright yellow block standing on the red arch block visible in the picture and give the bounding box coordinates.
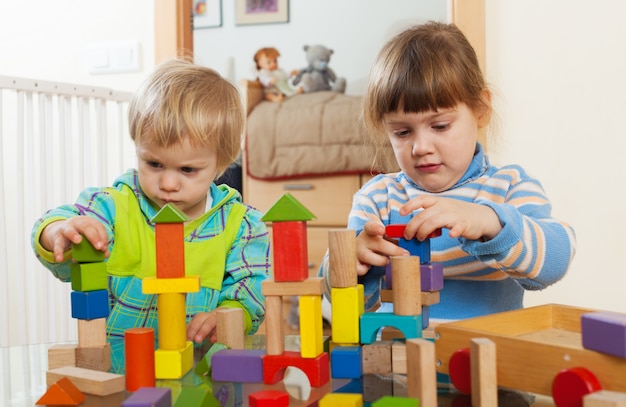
[300,295,324,358]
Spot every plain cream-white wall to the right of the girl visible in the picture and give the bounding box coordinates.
[486,0,626,312]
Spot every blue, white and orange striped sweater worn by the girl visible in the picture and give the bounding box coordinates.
[320,144,576,320]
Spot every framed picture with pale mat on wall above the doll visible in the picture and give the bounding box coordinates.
[235,0,289,25]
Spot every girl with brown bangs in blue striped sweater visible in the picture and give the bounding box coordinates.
[320,22,575,320]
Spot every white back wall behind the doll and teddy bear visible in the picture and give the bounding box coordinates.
[194,0,448,94]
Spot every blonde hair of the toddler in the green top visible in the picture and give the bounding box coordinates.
[128,59,245,176]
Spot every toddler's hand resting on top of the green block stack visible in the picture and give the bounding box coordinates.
[39,216,109,263]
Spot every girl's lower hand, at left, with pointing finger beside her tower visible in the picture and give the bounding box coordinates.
[356,220,410,276]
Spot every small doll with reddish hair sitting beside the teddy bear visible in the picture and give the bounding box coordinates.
[254,47,302,102]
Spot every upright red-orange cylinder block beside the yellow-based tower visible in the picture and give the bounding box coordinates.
[124,328,156,391]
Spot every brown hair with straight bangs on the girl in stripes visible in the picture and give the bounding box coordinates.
[363,22,491,133]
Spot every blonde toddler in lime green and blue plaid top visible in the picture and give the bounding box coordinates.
[32,60,270,371]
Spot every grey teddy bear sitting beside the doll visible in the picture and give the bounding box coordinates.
[292,45,346,93]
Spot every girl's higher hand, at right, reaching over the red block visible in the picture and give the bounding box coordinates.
[400,195,502,240]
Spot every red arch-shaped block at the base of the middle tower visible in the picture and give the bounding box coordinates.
[263,351,330,387]
